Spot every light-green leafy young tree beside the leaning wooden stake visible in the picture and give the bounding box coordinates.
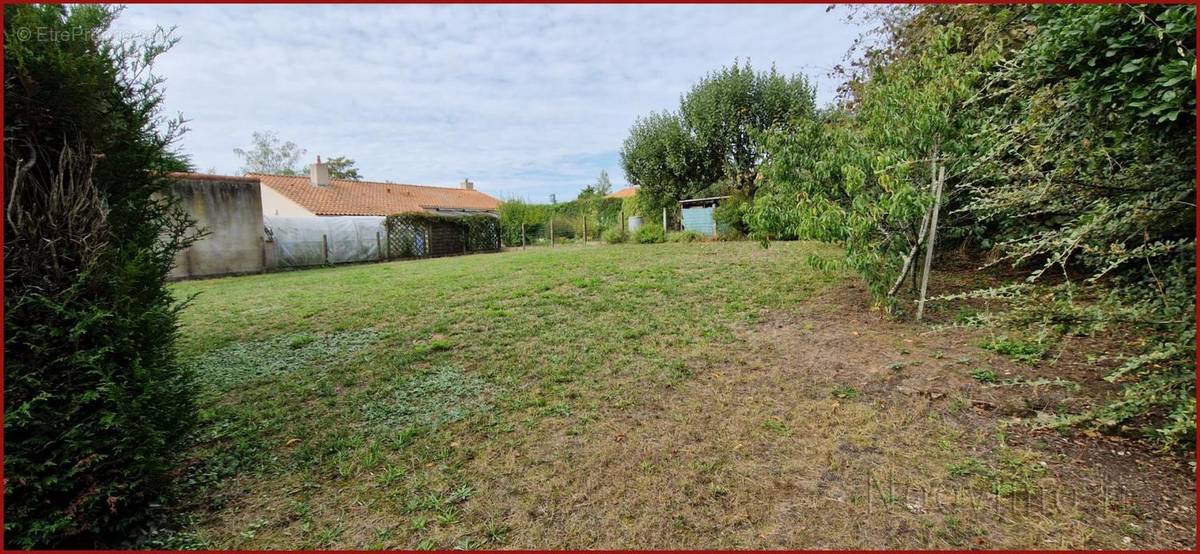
[748,23,978,304]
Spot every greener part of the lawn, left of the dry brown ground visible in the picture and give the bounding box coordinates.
[166,242,852,548]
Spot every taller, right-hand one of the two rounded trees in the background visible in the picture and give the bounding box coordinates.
[679,60,815,199]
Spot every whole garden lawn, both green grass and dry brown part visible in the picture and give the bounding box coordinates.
[162,242,1194,549]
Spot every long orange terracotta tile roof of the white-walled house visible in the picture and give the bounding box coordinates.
[250,173,500,216]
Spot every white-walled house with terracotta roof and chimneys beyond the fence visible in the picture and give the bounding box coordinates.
[258,157,500,217]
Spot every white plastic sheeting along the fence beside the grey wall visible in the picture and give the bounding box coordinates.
[263,216,425,267]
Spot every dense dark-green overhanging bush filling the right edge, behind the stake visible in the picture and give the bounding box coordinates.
[962,5,1196,445]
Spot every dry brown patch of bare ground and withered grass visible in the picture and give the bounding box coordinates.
[463,281,1195,548]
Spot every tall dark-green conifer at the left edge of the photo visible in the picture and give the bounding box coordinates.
[4,5,196,548]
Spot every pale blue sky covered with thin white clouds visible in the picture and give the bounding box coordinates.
[112,5,865,203]
